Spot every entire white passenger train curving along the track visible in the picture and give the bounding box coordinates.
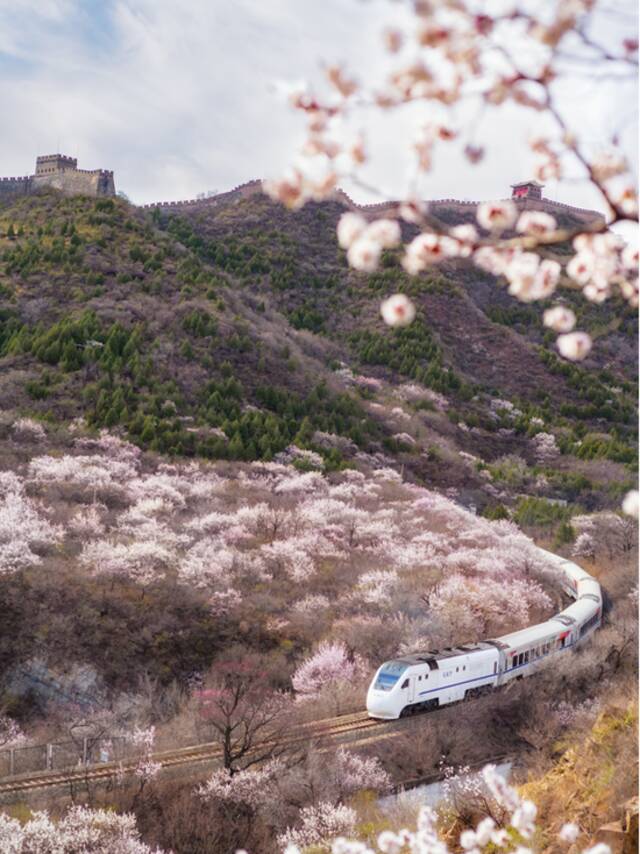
[367,552,602,719]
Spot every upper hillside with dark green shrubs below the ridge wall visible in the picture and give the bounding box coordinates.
[0,193,636,512]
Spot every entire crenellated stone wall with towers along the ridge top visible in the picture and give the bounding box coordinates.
[0,154,604,222]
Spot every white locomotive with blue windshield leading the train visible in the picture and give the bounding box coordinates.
[367,641,500,719]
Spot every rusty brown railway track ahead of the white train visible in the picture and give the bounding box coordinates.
[0,712,380,795]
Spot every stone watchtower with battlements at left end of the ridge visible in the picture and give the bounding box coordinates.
[0,154,116,199]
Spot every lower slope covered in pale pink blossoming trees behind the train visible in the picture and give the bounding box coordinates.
[0,419,553,716]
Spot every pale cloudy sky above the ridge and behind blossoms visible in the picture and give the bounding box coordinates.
[0,0,637,207]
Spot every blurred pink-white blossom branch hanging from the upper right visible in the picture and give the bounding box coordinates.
[264,0,638,360]
